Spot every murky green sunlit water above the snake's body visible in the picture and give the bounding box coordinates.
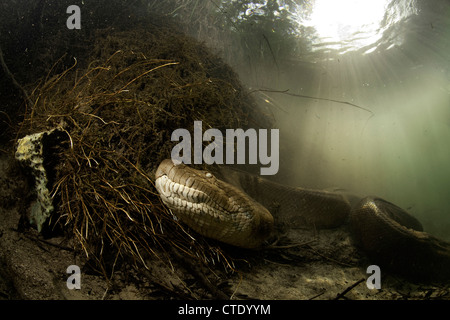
[151,0,450,239]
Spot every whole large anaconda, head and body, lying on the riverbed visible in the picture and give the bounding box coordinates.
[155,159,450,280]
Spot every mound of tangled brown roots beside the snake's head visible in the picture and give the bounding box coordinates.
[15,27,270,273]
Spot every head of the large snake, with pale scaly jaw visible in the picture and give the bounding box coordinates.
[155,159,274,248]
